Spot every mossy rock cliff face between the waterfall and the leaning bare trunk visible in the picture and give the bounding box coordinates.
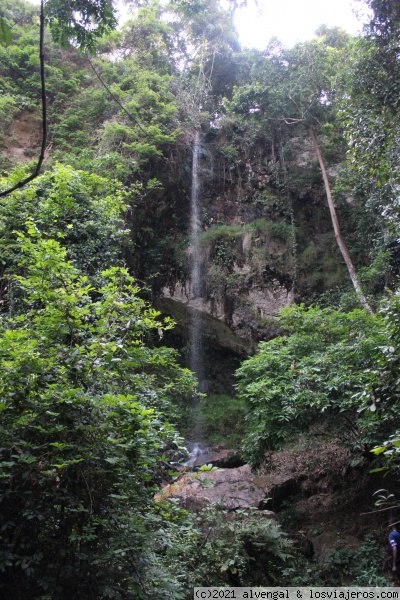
[157,131,346,356]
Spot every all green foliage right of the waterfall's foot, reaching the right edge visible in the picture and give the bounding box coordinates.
[237,292,400,470]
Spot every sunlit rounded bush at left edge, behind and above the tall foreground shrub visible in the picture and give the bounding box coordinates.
[0,165,128,284]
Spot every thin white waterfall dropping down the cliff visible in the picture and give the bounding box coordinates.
[189,131,203,398]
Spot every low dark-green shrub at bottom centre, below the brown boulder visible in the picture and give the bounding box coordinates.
[159,506,292,598]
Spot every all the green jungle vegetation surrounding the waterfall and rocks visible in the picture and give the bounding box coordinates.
[0,0,400,600]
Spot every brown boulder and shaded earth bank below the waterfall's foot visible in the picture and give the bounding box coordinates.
[157,441,394,561]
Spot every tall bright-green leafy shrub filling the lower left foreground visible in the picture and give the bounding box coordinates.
[0,227,193,600]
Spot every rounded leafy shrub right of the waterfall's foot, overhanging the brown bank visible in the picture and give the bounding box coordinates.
[237,306,385,465]
